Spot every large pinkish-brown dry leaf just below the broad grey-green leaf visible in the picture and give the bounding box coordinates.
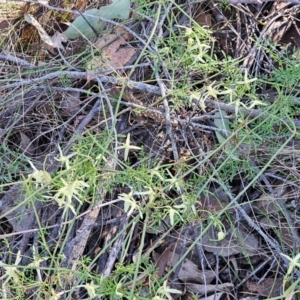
[87,34,136,80]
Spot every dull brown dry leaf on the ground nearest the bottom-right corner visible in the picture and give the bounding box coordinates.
[246,278,283,297]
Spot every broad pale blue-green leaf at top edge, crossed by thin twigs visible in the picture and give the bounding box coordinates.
[63,0,130,39]
